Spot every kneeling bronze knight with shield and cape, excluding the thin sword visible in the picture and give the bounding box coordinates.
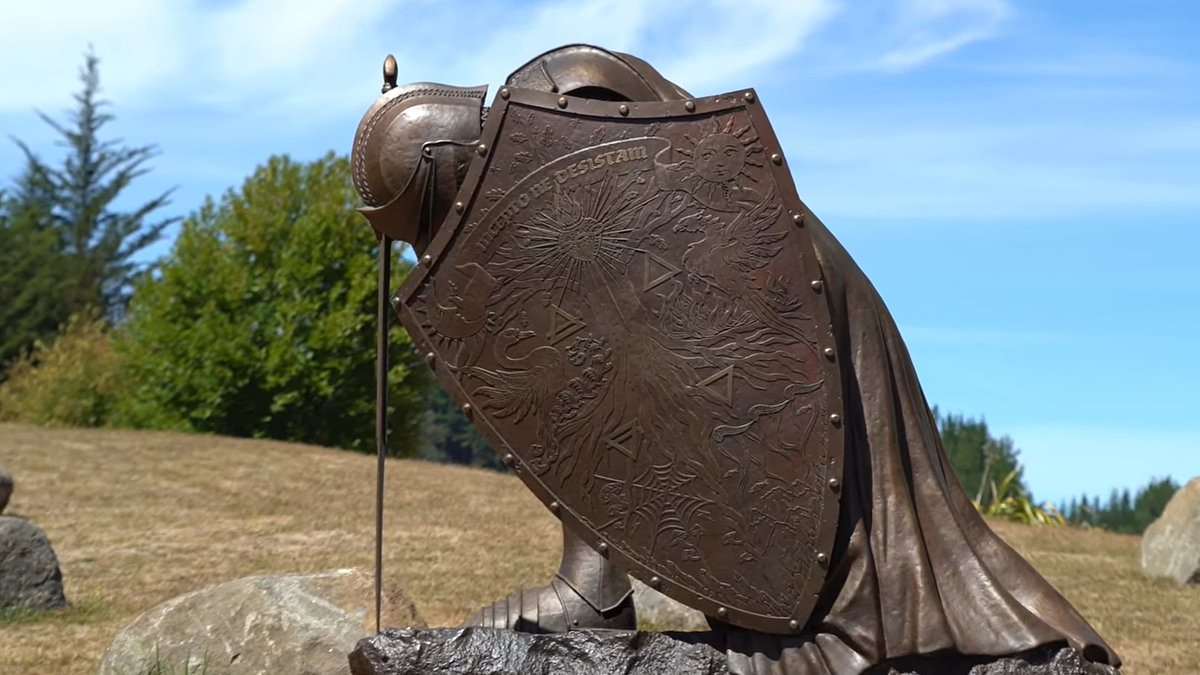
[352,44,1118,674]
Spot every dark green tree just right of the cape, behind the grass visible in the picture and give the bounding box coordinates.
[934,408,1028,503]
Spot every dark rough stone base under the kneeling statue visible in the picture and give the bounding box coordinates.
[349,628,1117,675]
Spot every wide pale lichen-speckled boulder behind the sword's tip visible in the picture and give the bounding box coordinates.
[100,569,425,675]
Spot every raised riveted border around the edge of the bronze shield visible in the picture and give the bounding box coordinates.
[391,86,848,634]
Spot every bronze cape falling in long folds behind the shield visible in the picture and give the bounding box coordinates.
[705,219,1120,675]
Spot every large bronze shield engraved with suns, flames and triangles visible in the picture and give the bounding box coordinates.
[395,89,842,633]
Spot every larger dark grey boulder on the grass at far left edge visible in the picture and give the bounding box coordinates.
[0,515,67,610]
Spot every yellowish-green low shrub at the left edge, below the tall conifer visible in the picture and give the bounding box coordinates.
[0,312,122,426]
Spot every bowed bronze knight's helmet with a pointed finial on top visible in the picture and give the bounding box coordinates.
[350,55,487,253]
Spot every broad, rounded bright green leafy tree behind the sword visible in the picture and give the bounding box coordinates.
[119,154,428,454]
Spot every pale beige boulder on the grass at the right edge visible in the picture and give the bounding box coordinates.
[1141,477,1200,584]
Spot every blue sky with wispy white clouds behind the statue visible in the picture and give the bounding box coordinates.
[0,0,1200,501]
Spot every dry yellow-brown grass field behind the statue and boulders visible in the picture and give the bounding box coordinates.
[0,425,1200,675]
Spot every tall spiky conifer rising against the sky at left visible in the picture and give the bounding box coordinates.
[10,52,178,317]
